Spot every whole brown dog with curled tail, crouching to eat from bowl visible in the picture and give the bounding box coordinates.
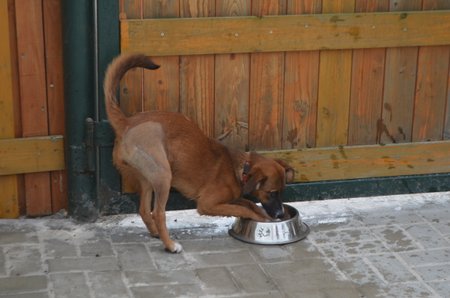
[104,54,294,252]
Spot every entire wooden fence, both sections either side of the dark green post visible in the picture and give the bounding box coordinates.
[0,0,450,217]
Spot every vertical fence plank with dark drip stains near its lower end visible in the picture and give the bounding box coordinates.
[378,0,422,144]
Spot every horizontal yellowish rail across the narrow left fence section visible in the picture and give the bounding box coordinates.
[0,135,65,176]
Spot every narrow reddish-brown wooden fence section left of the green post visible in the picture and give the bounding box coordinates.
[0,0,67,218]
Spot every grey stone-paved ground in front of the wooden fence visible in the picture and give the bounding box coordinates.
[0,193,450,298]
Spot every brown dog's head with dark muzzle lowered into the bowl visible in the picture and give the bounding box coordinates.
[243,153,294,218]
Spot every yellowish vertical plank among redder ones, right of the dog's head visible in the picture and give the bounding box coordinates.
[316,0,354,147]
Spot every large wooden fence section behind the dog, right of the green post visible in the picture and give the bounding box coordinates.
[121,0,450,189]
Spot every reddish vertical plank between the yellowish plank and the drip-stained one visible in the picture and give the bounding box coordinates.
[347,0,389,145]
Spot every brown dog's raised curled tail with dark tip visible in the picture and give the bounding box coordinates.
[103,54,159,135]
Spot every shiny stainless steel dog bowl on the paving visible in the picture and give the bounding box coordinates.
[228,204,309,244]
